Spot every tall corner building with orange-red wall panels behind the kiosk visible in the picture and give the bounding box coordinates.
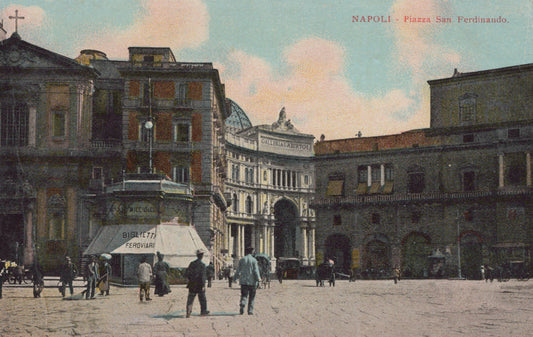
[77,47,228,267]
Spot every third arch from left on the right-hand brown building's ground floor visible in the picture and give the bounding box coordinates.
[401,232,431,278]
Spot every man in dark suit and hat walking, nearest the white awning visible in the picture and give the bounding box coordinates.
[185,249,209,318]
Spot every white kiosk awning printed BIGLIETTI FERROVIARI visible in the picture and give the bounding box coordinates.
[83,223,209,268]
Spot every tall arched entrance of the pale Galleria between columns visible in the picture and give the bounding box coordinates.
[274,199,298,257]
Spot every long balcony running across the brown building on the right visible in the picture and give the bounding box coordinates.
[311,186,533,208]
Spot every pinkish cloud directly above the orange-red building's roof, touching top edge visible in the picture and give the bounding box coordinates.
[78,0,209,58]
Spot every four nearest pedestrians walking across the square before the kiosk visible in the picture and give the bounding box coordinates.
[137,247,261,318]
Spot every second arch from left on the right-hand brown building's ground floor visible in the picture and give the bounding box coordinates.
[362,236,390,278]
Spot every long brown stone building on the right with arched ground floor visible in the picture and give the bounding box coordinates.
[312,64,533,279]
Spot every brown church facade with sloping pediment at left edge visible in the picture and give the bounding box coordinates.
[0,33,98,271]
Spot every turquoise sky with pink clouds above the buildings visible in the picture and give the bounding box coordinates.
[0,0,533,139]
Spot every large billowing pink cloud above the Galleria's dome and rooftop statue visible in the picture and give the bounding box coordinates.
[219,37,427,139]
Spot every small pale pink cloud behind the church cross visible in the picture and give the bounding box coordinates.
[0,4,46,39]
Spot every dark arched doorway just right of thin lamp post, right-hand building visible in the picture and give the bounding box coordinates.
[460,232,483,280]
